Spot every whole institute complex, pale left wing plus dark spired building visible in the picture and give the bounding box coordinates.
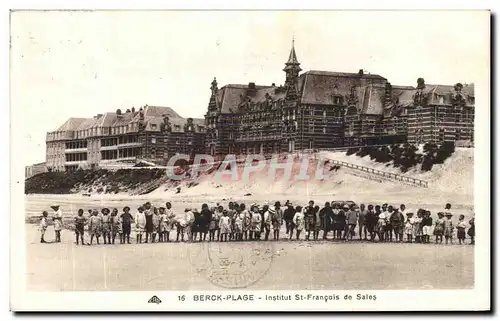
[46,45,474,171]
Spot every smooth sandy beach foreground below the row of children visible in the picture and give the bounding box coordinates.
[27,225,474,291]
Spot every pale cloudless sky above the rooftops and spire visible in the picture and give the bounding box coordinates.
[11,11,490,165]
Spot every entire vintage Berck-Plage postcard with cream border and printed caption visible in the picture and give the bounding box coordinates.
[10,10,491,311]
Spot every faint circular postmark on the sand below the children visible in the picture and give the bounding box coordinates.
[207,242,274,289]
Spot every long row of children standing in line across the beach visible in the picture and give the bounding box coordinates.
[40,201,475,245]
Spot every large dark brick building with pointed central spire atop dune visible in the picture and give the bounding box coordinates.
[205,45,474,157]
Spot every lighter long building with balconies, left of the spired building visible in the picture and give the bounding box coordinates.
[46,105,205,171]
